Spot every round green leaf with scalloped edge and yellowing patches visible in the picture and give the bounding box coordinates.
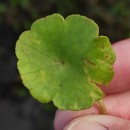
[16,14,115,110]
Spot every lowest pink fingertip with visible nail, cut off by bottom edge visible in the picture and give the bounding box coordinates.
[63,115,130,130]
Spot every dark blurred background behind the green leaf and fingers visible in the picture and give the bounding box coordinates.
[0,0,130,130]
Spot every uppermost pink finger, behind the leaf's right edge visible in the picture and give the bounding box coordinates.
[101,38,130,94]
